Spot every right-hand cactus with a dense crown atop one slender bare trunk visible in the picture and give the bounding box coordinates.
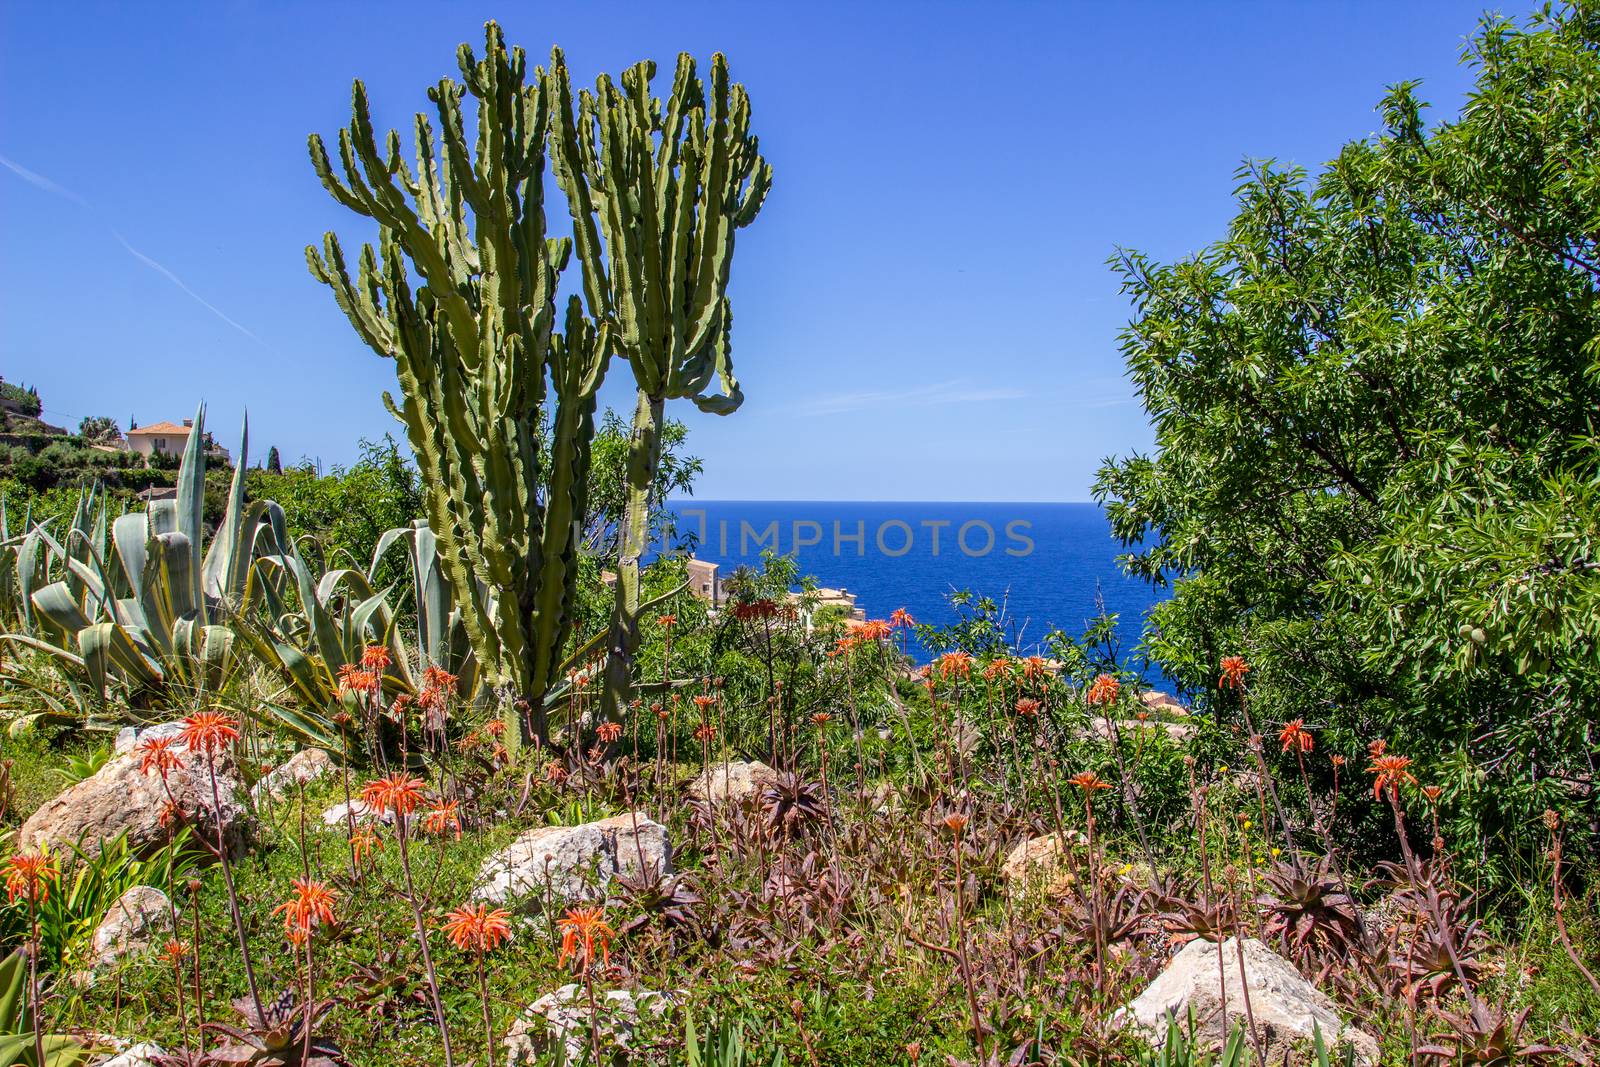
[546,50,773,715]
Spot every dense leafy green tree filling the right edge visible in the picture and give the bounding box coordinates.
[1096,3,1600,876]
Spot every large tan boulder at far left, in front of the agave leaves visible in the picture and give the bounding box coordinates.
[16,723,251,857]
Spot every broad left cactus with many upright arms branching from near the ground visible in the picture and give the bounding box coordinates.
[306,22,610,739]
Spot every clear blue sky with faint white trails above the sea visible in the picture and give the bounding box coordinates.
[0,0,1484,501]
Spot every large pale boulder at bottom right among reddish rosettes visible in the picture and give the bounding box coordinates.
[1114,937,1378,1064]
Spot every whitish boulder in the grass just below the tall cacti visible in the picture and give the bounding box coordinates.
[472,811,672,910]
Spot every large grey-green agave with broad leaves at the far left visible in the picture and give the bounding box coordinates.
[3,405,285,716]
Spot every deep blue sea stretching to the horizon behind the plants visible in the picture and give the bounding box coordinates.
[656,498,1163,681]
